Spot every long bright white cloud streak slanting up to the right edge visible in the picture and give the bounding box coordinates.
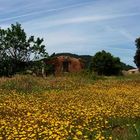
[21,12,140,31]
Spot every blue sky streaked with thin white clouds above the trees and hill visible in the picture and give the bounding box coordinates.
[0,0,140,66]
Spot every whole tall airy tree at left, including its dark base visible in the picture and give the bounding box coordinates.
[0,23,48,76]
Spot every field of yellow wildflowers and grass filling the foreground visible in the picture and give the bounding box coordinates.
[0,76,140,140]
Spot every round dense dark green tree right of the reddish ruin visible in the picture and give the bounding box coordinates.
[91,50,122,76]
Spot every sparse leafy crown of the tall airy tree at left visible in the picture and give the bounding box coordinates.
[0,23,47,61]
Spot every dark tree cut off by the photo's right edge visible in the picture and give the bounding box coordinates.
[134,37,140,70]
